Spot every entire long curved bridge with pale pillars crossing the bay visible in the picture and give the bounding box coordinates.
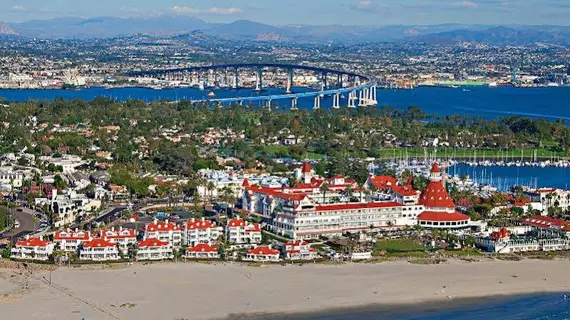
[125,63,377,110]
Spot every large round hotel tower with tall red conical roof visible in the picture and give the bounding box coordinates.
[417,163,469,229]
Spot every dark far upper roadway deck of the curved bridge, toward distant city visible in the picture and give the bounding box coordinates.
[126,63,369,81]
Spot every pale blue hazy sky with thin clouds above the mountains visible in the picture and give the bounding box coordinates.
[0,0,570,25]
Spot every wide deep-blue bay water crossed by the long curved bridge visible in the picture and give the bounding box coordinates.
[0,87,570,121]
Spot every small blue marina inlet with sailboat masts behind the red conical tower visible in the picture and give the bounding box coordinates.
[448,164,570,190]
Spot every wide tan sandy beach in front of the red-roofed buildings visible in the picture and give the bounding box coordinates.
[0,260,570,320]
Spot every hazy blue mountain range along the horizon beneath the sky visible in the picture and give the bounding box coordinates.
[0,15,570,45]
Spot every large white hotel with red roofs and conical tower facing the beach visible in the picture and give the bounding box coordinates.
[242,163,469,240]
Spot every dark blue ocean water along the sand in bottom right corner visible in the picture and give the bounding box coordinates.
[267,294,570,320]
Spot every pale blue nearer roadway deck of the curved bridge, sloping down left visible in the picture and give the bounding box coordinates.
[195,83,377,104]
